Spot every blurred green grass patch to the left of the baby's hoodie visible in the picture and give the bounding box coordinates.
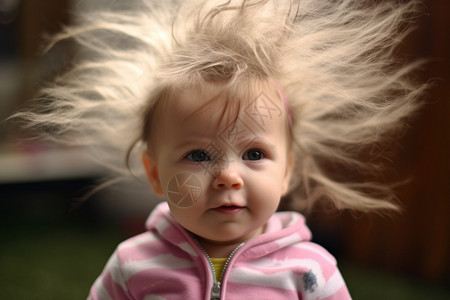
[0,228,119,300]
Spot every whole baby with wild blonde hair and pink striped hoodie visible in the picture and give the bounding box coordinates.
[12,0,422,299]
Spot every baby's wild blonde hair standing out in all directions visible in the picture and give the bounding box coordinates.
[11,0,424,211]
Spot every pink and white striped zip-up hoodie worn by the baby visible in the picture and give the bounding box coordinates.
[88,203,351,300]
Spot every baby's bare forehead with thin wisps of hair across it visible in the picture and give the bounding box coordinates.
[146,79,289,154]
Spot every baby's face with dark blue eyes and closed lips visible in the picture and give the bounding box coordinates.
[144,84,290,243]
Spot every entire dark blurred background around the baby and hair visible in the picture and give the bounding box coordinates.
[0,0,450,299]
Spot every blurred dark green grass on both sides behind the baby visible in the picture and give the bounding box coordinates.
[0,225,450,300]
